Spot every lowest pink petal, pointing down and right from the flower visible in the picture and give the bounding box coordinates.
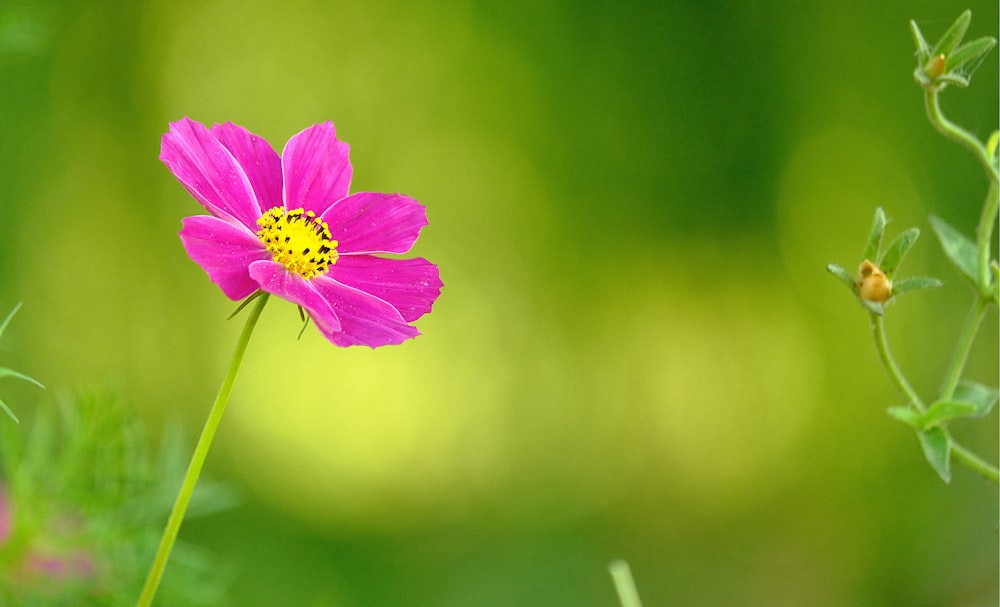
[309,274,420,348]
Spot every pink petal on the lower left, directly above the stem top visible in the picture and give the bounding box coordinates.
[180,215,271,300]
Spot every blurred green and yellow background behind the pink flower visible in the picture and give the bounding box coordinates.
[0,0,1000,607]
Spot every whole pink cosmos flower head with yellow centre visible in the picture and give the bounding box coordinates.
[160,118,442,348]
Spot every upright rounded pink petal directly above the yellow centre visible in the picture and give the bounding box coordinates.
[281,122,352,214]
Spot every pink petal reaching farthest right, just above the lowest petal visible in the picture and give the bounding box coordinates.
[327,255,442,322]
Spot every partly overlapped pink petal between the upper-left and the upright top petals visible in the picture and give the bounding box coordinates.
[210,122,281,214]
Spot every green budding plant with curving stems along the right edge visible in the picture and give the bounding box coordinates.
[827,11,1000,482]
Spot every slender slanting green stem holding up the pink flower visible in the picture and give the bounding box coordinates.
[136,293,268,607]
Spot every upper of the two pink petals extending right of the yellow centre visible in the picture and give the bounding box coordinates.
[321,192,427,254]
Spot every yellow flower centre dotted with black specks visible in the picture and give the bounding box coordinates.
[257,207,337,279]
